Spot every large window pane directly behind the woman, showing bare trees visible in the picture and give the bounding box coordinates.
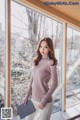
[11,1,62,118]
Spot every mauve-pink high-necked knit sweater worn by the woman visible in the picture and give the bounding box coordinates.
[26,58,58,106]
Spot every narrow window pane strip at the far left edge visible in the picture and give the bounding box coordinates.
[0,0,5,108]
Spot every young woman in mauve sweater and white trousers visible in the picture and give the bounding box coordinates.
[24,38,58,120]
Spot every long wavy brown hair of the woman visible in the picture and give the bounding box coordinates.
[34,37,57,65]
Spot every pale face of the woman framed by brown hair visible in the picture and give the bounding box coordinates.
[39,41,49,56]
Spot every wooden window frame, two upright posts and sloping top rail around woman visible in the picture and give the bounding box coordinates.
[6,0,80,111]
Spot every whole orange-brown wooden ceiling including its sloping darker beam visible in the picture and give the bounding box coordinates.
[19,0,80,29]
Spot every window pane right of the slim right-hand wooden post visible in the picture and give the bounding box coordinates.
[66,27,80,107]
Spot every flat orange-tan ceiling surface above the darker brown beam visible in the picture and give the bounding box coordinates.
[40,0,80,22]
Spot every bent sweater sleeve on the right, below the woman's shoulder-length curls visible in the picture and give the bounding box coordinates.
[41,61,58,106]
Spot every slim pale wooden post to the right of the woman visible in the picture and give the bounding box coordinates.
[62,23,67,112]
